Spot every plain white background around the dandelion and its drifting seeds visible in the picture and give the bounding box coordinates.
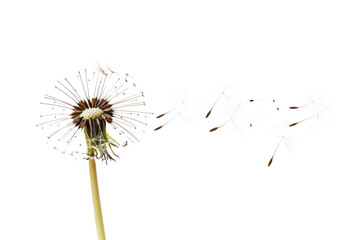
[0,0,360,240]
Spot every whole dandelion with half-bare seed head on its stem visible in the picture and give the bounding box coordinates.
[37,68,151,239]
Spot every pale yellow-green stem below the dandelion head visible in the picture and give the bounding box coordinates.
[89,157,105,240]
